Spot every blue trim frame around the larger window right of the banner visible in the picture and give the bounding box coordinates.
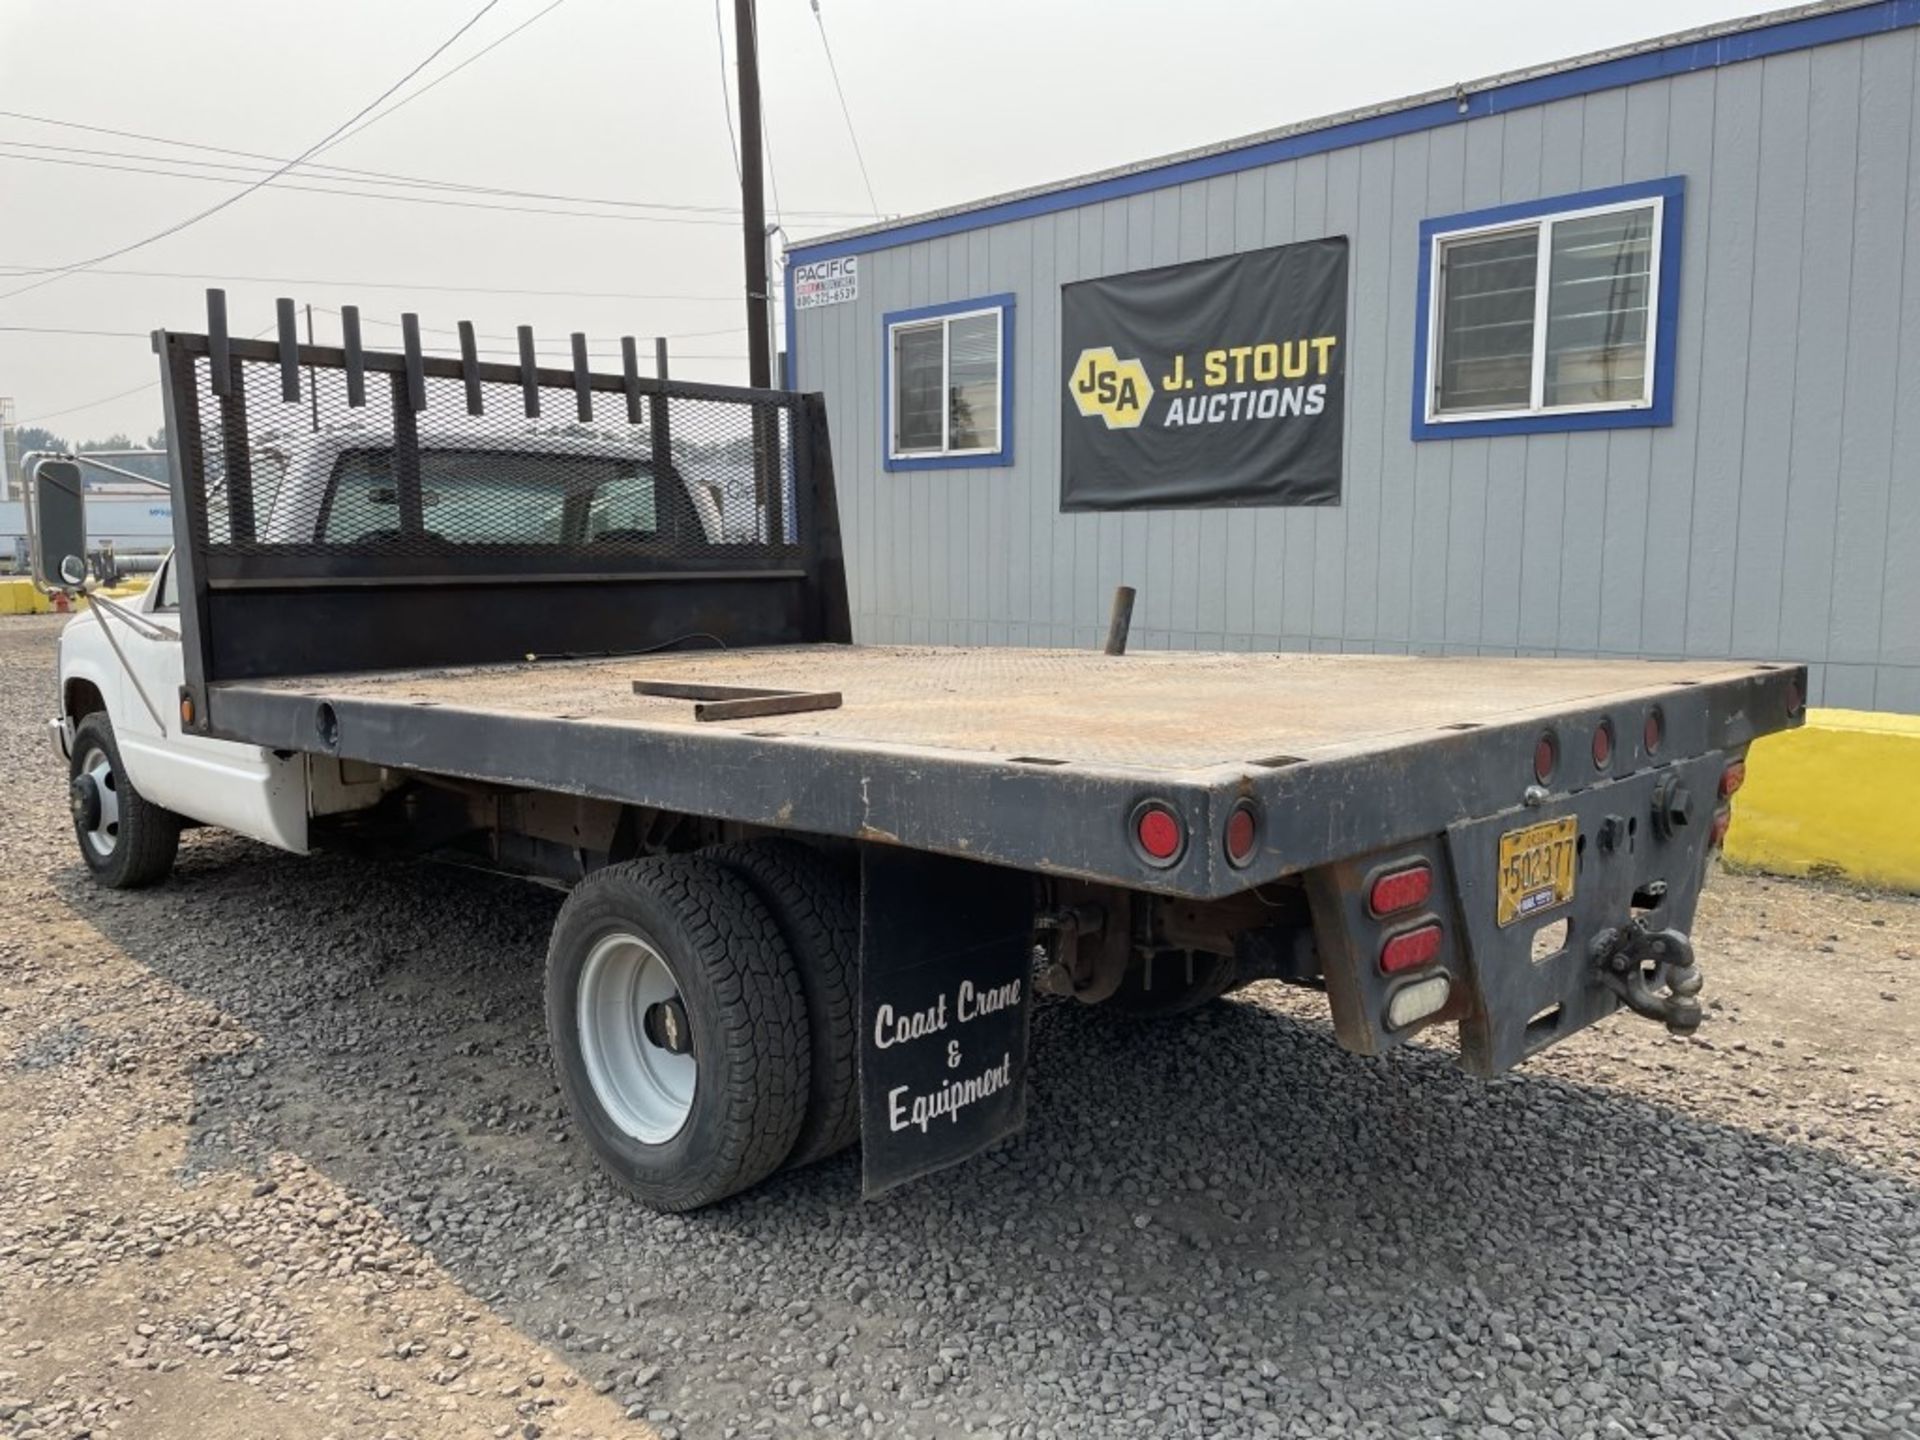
[1413,175,1686,440]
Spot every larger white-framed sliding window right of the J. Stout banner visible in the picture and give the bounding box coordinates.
[1428,200,1661,419]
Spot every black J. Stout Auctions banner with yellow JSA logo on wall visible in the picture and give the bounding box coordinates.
[1060,236,1346,511]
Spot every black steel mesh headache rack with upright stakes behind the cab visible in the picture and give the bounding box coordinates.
[154,290,851,710]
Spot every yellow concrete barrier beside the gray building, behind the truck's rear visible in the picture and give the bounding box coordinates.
[1726,710,1920,891]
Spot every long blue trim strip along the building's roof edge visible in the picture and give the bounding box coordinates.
[787,0,1920,286]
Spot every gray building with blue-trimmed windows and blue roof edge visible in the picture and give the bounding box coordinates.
[787,0,1920,712]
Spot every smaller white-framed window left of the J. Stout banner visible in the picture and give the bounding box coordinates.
[889,309,1006,457]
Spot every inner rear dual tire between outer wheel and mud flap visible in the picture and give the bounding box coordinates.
[705,839,860,1167]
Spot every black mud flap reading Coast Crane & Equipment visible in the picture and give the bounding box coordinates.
[860,845,1033,1196]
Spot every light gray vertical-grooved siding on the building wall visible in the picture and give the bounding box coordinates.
[797,29,1920,710]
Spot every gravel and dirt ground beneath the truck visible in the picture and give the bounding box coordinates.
[0,620,1920,1440]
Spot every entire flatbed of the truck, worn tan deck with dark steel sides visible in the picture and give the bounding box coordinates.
[215,645,1799,893]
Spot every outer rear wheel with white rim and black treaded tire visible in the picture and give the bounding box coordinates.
[547,856,810,1212]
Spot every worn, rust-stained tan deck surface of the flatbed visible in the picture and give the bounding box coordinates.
[236,645,1781,772]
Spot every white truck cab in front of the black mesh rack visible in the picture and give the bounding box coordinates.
[52,426,728,876]
